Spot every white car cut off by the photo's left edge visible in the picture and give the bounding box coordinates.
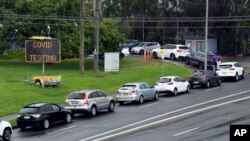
[0,120,12,141]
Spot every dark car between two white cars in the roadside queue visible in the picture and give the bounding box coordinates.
[189,70,221,88]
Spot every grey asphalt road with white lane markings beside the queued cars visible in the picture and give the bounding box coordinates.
[9,75,250,141]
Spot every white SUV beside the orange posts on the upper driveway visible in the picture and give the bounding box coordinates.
[152,44,189,60]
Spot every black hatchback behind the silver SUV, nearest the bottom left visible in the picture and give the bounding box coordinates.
[17,103,71,130]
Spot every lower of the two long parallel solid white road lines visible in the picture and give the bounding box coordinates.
[94,96,250,141]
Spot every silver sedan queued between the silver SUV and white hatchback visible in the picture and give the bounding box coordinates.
[116,82,159,105]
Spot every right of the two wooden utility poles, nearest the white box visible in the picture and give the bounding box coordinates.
[94,0,100,74]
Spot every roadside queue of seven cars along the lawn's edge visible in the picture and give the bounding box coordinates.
[0,62,244,141]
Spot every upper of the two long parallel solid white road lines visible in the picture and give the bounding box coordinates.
[80,90,250,141]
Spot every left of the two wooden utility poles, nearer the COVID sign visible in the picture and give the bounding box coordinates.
[80,0,85,74]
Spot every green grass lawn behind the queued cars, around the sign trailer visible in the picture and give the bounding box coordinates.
[0,58,192,117]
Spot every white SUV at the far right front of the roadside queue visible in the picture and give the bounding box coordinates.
[216,62,244,81]
